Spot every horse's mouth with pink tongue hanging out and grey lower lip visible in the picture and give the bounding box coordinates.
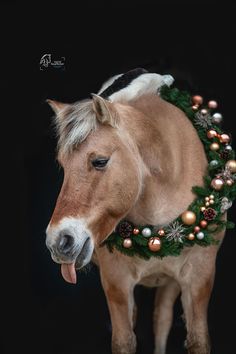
[61,237,91,284]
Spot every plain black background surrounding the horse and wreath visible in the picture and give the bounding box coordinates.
[1,1,236,354]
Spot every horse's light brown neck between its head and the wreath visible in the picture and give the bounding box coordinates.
[125,97,207,225]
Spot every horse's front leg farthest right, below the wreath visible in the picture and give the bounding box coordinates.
[180,246,215,354]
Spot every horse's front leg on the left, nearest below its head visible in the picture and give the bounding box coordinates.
[101,270,136,354]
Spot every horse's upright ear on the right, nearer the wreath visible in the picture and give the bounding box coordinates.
[91,93,118,127]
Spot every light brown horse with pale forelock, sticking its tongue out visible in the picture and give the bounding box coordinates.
[46,90,224,354]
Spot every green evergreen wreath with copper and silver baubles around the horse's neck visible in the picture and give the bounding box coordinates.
[103,86,236,259]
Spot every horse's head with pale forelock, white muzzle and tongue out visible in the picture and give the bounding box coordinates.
[46,95,144,282]
